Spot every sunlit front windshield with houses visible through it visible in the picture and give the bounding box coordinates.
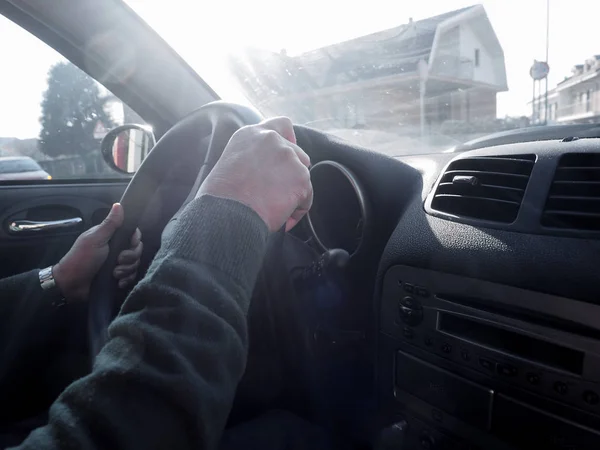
[128,0,600,155]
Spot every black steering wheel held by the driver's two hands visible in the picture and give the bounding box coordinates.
[88,101,262,358]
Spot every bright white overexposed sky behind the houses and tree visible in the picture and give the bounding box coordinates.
[0,0,600,138]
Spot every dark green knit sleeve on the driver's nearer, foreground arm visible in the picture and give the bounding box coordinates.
[10,196,268,450]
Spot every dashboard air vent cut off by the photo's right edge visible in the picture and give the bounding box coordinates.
[542,153,600,231]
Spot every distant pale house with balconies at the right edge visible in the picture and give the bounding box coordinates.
[530,55,600,124]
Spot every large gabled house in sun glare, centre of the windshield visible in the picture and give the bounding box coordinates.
[231,5,507,132]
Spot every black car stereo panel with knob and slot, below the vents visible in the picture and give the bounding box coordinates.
[378,266,600,449]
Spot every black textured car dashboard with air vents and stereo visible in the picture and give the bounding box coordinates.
[296,127,600,449]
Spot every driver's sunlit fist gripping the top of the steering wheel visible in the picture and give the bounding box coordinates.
[198,117,313,231]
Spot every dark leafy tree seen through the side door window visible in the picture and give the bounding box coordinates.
[39,62,115,160]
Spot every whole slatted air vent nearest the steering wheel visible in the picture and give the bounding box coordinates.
[431,155,535,223]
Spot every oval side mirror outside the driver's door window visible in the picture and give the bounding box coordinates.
[101,124,156,174]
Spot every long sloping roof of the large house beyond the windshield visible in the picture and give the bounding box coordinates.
[225,5,506,106]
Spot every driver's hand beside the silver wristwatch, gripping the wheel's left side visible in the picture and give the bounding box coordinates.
[52,203,143,301]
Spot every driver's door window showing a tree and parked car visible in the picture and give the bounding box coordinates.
[0,15,145,183]
